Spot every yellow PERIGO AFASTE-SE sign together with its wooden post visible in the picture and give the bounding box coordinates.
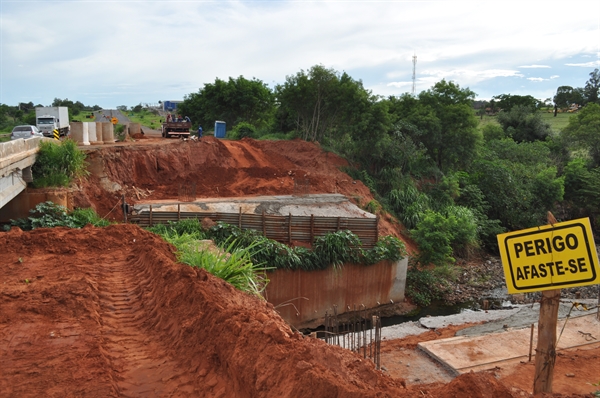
[498,212,600,395]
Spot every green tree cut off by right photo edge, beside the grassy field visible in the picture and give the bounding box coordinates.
[563,103,600,167]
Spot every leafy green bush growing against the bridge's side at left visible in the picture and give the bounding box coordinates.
[31,140,88,188]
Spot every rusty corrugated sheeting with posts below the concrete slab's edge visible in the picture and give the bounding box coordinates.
[129,206,379,248]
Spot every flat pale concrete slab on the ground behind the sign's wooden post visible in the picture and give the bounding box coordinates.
[418,311,600,375]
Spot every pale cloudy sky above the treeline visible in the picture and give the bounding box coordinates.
[0,0,600,108]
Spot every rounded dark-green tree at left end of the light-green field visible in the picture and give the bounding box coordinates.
[498,105,551,142]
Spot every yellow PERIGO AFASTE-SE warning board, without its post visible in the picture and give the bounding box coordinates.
[497,218,600,293]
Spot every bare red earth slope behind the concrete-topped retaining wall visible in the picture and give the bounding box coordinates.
[74,137,414,252]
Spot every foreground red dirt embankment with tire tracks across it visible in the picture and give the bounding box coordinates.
[0,225,540,397]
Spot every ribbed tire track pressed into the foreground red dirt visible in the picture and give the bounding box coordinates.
[92,255,189,397]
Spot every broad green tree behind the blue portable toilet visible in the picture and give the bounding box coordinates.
[178,76,275,133]
